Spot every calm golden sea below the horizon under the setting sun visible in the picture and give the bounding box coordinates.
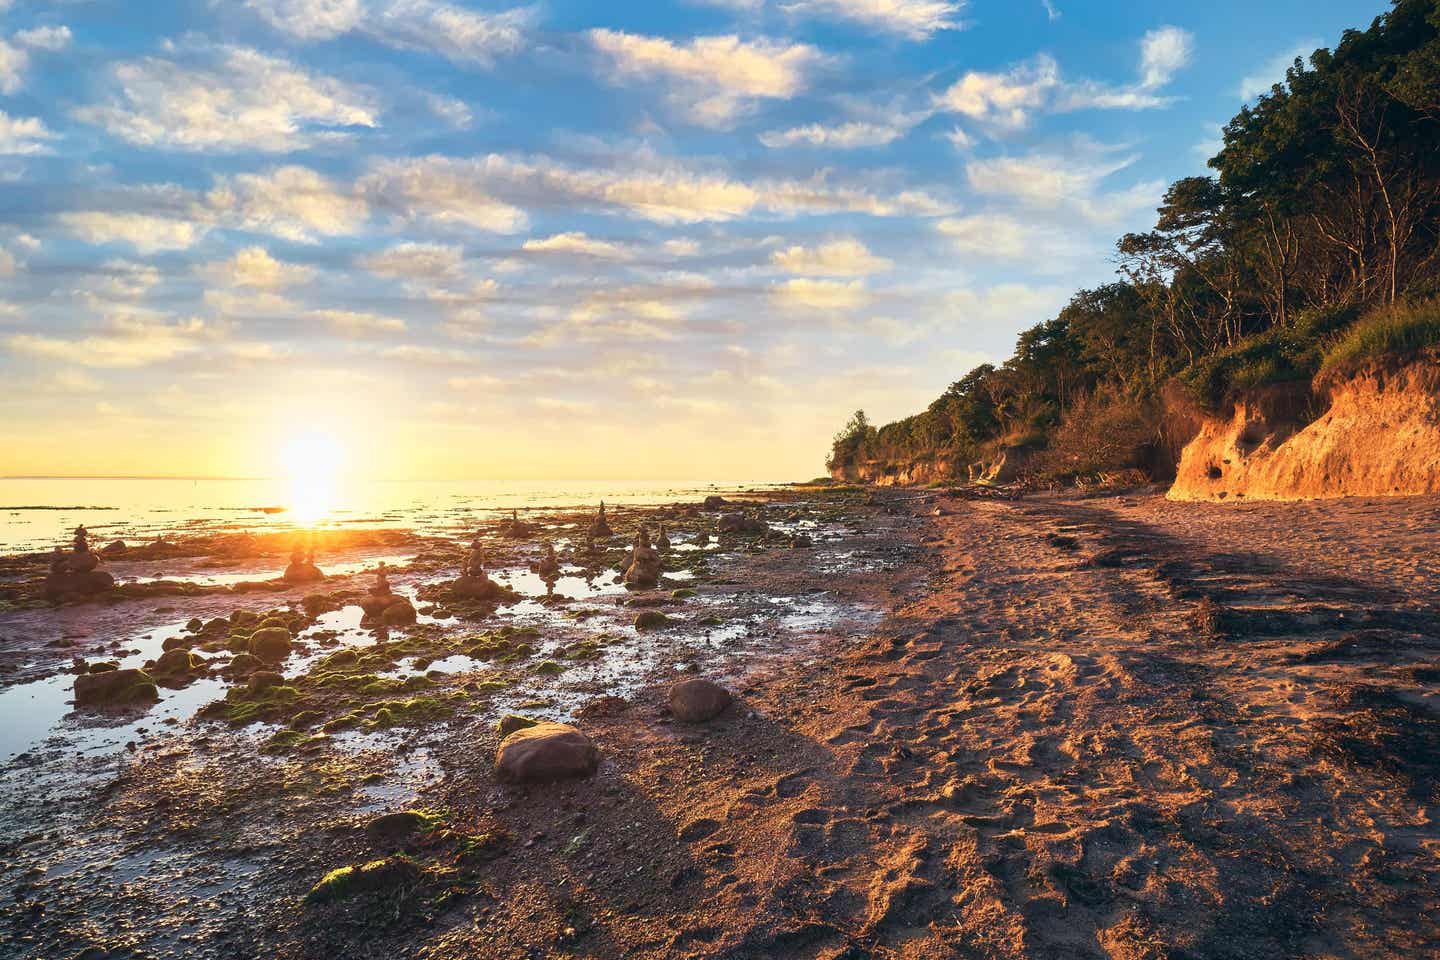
[0,478,766,553]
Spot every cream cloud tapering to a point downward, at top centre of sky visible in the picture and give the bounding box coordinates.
[589,30,825,127]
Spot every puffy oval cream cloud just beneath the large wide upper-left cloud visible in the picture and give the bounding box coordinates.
[206,166,369,242]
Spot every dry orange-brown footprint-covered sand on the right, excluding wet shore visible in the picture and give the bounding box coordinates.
[391,498,1440,959]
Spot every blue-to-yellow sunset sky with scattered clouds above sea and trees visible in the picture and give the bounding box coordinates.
[0,0,1384,479]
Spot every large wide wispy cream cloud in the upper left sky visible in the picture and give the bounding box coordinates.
[75,46,379,153]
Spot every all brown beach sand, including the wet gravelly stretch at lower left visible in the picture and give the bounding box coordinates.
[0,491,1440,960]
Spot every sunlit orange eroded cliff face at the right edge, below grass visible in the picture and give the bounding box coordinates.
[1169,353,1440,501]
